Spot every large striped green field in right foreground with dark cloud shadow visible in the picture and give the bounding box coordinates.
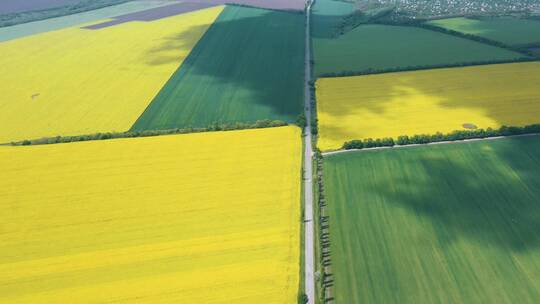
[324,136,540,304]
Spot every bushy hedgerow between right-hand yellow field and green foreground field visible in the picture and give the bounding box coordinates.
[342,124,540,150]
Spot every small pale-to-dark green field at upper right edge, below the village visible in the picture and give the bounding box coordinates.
[428,17,540,46]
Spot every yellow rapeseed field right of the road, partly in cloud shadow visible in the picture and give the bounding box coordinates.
[316,62,540,150]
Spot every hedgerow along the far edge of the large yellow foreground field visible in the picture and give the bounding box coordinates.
[11,120,288,146]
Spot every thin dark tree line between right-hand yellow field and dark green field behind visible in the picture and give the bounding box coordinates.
[320,57,538,77]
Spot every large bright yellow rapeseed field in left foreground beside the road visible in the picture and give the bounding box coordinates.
[0,127,301,304]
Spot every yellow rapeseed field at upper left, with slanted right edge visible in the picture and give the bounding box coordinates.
[0,6,223,143]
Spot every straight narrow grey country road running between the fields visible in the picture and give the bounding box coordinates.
[304,0,315,304]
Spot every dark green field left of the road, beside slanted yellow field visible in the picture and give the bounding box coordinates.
[132,6,305,131]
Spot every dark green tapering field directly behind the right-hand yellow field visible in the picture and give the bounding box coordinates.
[313,24,524,76]
